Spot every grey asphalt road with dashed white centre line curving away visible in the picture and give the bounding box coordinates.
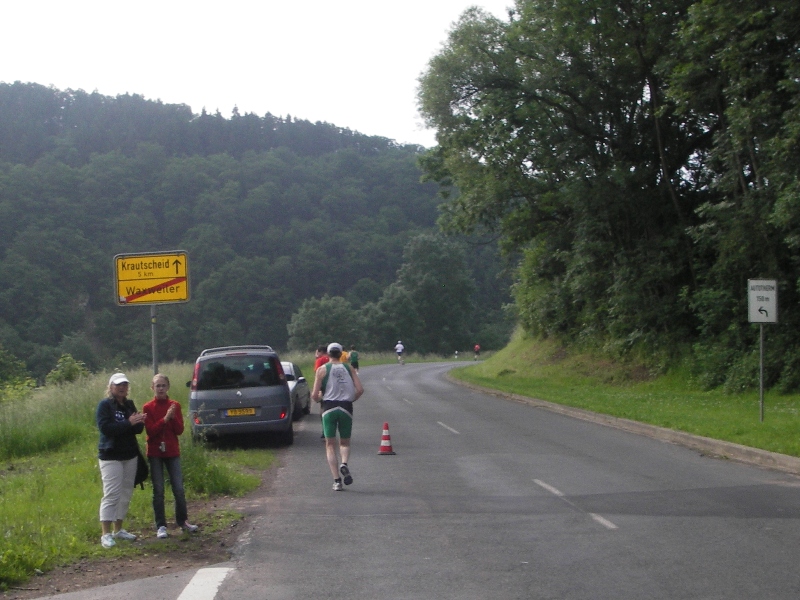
[40,363,800,600]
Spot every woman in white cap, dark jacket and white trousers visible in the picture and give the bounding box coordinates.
[96,373,144,548]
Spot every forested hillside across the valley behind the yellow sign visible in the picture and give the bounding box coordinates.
[0,82,510,380]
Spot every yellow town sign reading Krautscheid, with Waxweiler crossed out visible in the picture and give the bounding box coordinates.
[114,250,189,306]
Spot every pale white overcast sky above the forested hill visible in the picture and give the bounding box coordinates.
[0,0,514,147]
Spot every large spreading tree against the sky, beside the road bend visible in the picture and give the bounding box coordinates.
[419,0,699,348]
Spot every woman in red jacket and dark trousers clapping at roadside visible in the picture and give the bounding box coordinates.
[142,373,197,538]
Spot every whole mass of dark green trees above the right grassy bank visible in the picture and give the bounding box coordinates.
[419,0,800,391]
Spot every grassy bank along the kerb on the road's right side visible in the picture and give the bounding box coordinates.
[452,333,800,456]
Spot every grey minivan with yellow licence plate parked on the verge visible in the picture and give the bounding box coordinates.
[187,346,294,444]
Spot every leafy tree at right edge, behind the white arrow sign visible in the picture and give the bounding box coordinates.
[669,0,800,390]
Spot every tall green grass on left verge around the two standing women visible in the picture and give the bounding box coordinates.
[0,364,275,589]
